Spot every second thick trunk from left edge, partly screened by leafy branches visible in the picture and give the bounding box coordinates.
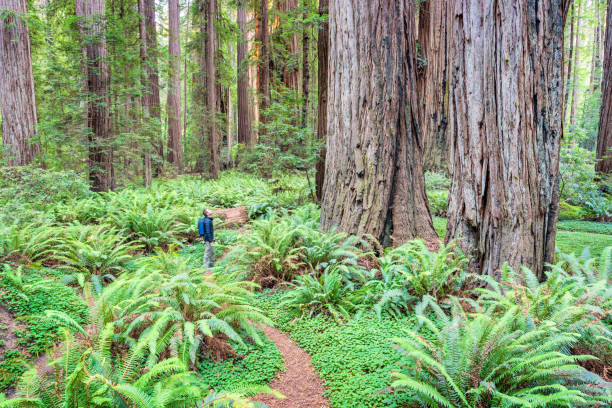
[75,0,113,191]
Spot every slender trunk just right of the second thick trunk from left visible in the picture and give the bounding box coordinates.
[138,0,155,186]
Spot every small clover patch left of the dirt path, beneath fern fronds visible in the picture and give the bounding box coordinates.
[198,334,283,394]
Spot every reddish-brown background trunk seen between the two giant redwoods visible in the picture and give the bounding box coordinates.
[417,0,455,171]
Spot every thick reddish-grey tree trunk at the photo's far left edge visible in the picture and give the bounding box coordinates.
[0,0,40,166]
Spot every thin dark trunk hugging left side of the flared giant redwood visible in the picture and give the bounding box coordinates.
[315,0,329,202]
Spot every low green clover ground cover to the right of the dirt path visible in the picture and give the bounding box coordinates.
[257,292,415,408]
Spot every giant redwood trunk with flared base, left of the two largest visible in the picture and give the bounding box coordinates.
[321,0,437,245]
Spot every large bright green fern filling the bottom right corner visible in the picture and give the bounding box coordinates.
[392,299,612,408]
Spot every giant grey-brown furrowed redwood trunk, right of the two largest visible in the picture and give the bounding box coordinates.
[446,0,567,279]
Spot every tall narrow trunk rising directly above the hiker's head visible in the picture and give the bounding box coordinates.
[206,0,219,179]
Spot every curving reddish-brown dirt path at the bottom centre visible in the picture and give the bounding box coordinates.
[253,327,329,408]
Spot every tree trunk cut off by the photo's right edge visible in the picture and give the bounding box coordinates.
[595,0,612,173]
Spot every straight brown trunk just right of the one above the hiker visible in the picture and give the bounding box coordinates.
[237,0,252,146]
